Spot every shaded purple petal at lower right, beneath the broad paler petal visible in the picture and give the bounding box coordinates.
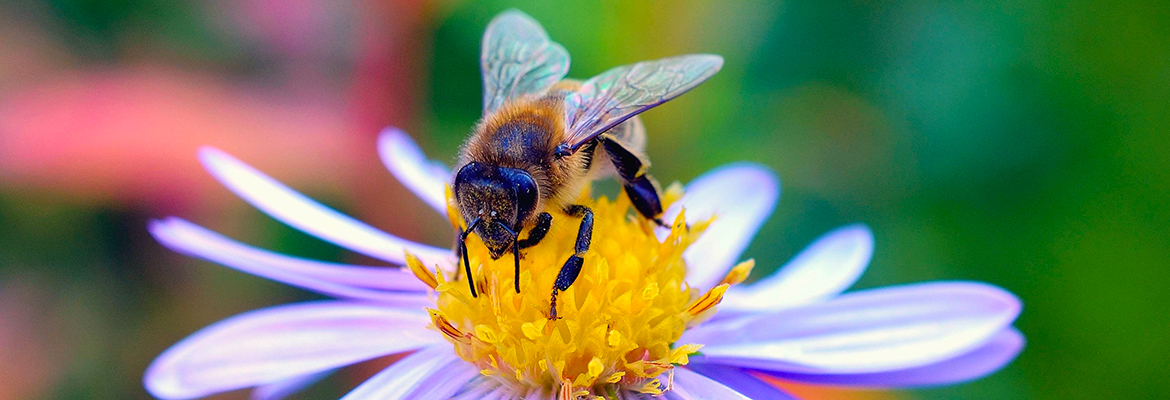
[765,327,1024,388]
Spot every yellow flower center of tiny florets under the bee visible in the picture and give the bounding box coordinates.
[407,185,751,399]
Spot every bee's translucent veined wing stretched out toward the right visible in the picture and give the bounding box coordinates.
[565,54,723,151]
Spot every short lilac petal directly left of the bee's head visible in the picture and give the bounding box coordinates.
[378,127,450,215]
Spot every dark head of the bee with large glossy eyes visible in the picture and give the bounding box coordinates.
[452,161,537,258]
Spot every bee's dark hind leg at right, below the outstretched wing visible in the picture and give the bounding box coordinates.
[598,133,665,226]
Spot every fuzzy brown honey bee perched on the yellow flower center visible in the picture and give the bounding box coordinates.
[452,11,723,319]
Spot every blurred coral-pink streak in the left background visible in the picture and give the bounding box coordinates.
[0,67,373,201]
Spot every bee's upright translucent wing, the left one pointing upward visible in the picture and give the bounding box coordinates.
[480,9,569,113]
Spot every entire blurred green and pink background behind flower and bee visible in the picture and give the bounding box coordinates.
[0,0,1170,400]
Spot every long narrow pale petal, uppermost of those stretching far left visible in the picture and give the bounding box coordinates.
[199,147,453,265]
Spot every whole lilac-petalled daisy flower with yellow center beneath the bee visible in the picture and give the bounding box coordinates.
[144,129,1024,400]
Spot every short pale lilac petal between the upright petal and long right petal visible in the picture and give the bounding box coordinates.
[720,225,874,312]
